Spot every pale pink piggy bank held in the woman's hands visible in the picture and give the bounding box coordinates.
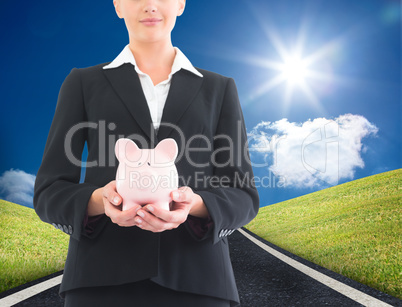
[115,138,179,210]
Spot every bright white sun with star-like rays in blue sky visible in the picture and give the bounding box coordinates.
[245,23,342,114]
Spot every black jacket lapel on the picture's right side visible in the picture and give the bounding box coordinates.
[158,69,203,140]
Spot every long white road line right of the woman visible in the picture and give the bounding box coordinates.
[238,229,392,307]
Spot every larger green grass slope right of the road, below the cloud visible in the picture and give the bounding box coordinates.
[246,169,402,298]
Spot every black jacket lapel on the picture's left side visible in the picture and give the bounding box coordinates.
[104,63,155,146]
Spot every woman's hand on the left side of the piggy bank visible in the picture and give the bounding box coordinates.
[88,181,141,227]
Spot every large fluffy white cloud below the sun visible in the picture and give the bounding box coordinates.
[249,114,378,188]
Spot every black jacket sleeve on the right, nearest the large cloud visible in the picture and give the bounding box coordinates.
[190,79,259,243]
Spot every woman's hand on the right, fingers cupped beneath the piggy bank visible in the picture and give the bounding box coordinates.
[134,187,208,232]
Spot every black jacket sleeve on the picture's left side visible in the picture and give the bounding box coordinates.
[34,69,105,240]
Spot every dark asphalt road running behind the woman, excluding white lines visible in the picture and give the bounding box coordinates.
[0,231,402,307]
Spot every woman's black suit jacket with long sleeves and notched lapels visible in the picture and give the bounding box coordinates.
[34,64,259,301]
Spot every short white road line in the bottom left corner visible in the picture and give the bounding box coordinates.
[0,275,63,307]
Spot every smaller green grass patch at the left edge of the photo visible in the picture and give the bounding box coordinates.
[0,200,69,292]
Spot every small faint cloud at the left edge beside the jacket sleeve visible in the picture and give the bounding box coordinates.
[0,169,35,207]
